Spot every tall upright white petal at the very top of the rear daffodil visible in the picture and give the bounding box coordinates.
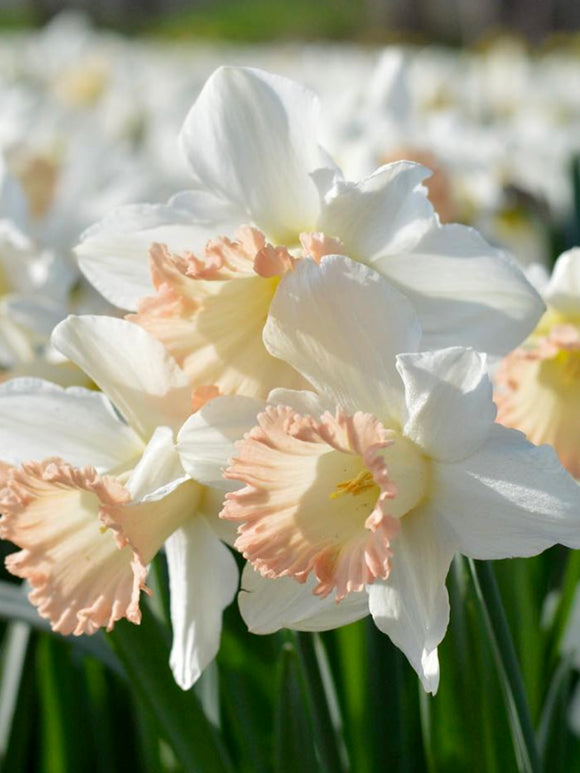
[181,67,327,243]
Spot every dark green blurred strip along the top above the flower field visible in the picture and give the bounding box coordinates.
[0,0,580,45]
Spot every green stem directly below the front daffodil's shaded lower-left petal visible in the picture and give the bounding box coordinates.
[294,631,346,773]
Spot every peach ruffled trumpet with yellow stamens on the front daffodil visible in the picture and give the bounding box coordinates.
[221,406,429,601]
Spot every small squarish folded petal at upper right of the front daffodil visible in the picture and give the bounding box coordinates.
[397,347,497,462]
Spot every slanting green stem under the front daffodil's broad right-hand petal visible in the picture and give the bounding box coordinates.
[469,559,541,773]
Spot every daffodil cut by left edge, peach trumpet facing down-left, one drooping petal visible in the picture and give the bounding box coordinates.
[0,317,238,688]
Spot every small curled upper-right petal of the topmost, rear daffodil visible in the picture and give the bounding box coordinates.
[317,161,435,265]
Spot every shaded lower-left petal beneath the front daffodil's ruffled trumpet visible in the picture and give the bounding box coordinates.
[238,564,369,634]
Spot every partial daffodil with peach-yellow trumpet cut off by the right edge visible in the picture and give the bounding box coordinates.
[495,247,580,478]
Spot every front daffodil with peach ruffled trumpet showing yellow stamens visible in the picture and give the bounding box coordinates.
[178,256,580,692]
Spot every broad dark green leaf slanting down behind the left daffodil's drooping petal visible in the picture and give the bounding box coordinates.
[109,604,233,773]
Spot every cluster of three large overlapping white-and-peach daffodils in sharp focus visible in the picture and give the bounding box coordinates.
[0,68,580,692]
